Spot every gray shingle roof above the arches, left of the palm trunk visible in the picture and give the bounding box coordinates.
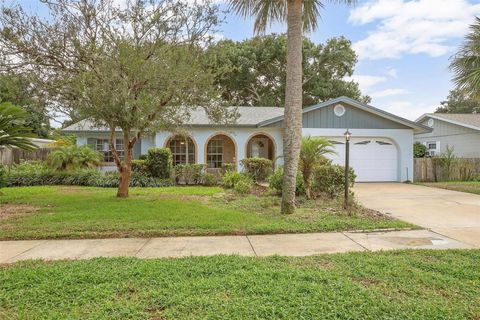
[62,107,284,132]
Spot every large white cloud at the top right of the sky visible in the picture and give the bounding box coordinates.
[349,0,480,60]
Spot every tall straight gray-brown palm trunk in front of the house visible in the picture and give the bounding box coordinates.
[282,0,303,214]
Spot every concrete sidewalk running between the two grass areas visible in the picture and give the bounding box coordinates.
[0,230,474,263]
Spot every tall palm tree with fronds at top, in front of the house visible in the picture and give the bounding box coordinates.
[229,0,356,214]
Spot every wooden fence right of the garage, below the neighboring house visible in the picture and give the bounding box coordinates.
[413,158,480,182]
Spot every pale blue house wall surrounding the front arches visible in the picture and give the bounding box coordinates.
[156,127,283,170]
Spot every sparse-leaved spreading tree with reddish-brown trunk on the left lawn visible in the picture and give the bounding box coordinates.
[0,0,234,197]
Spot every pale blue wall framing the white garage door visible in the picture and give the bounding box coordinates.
[302,128,413,181]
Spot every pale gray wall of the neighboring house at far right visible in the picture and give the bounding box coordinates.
[415,118,480,158]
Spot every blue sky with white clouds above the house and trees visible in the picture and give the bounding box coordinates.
[10,0,480,120]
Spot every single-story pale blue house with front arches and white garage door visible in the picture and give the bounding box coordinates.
[63,97,430,182]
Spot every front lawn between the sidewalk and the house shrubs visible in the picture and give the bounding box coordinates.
[0,186,413,239]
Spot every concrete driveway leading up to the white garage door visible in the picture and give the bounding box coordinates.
[354,183,480,247]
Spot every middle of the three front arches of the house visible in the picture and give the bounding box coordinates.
[205,133,237,170]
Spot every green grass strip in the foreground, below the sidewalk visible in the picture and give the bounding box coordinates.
[0,250,480,320]
